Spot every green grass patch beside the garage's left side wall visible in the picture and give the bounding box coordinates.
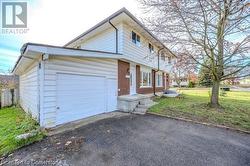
[0,107,44,156]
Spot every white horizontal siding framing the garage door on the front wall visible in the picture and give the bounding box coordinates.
[43,56,118,127]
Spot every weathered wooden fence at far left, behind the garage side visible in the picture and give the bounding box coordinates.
[0,89,18,108]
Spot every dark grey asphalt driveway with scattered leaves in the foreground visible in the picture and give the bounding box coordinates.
[2,115,250,166]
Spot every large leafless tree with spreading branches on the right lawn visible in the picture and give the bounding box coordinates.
[140,0,250,107]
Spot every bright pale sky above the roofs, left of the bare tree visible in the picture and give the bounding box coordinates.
[0,0,141,73]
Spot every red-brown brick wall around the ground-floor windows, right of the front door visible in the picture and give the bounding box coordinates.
[136,65,165,94]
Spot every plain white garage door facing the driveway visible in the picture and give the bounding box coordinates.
[56,74,108,125]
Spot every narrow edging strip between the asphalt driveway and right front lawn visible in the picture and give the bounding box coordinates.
[147,112,250,134]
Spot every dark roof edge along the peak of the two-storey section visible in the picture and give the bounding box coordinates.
[64,7,175,56]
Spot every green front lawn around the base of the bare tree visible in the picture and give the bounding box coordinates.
[149,89,250,131]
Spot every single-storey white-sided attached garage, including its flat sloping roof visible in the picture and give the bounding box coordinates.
[14,44,120,128]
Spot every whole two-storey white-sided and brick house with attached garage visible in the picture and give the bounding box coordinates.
[13,8,175,128]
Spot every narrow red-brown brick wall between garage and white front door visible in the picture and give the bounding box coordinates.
[118,60,130,96]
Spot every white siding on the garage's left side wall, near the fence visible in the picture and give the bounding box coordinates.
[19,62,39,120]
